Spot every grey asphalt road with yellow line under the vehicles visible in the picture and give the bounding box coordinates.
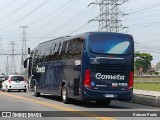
[0,91,160,120]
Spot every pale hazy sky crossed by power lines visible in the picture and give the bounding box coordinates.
[0,0,160,72]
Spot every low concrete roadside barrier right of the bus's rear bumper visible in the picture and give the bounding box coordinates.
[132,89,160,107]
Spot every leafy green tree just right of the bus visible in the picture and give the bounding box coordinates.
[135,52,153,73]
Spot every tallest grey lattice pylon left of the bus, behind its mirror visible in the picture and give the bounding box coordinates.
[20,26,28,73]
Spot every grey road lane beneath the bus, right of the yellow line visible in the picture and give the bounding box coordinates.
[0,92,160,111]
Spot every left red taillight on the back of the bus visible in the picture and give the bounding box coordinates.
[84,70,91,87]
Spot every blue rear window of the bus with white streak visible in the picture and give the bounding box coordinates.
[90,35,131,54]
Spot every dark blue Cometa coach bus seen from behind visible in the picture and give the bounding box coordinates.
[24,32,134,104]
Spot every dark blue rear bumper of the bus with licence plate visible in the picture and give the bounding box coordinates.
[83,88,133,100]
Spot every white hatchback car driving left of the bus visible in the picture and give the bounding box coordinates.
[2,75,27,92]
